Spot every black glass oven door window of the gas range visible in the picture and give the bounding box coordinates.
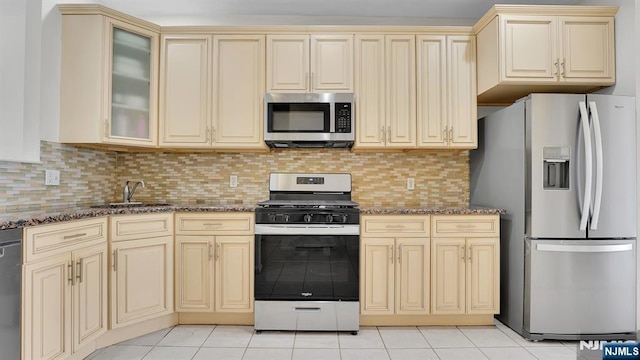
[255,235,359,301]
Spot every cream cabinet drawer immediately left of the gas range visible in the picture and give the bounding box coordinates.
[176,212,254,235]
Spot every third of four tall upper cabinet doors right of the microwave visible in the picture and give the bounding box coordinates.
[416,35,448,148]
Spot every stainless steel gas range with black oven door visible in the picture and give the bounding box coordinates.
[254,173,360,333]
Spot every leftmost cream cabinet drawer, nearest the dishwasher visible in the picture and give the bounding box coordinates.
[24,217,107,263]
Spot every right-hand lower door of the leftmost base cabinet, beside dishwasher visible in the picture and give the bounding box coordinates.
[72,243,107,351]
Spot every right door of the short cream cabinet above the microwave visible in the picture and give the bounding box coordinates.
[310,35,353,92]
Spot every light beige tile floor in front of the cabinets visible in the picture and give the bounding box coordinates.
[87,322,577,360]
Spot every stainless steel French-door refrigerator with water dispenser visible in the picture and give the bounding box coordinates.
[470,94,636,340]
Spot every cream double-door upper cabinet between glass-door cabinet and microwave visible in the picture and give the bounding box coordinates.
[160,35,266,150]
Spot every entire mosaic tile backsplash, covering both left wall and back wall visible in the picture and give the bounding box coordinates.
[0,141,469,213]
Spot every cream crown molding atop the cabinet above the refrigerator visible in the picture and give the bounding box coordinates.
[473,4,618,35]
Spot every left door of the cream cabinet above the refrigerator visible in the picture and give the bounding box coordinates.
[501,15,558,83]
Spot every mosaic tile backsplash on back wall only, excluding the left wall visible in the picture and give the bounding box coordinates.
[117,149,469,207]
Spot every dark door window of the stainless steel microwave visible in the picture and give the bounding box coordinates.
[267,103,331,133]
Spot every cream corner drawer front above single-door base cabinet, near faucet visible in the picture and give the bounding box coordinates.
[110,213,173,241]
